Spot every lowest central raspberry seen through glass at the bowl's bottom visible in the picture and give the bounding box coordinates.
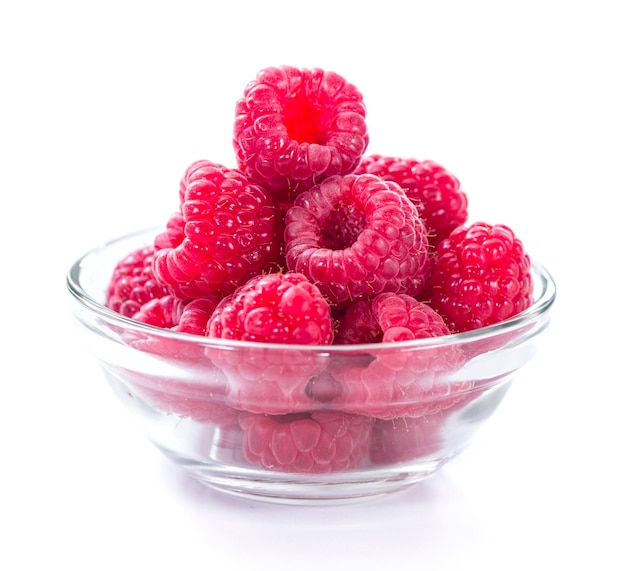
[239,411,372,474]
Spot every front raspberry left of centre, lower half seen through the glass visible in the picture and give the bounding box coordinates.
[208,273,333,414]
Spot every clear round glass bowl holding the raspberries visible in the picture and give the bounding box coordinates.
[67,229,556,504]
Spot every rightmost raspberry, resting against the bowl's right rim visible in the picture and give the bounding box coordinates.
[430,222,532,332]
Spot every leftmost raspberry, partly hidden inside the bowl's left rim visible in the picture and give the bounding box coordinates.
[105,246,168,318]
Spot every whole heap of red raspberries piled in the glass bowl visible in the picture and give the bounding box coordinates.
[106,66,532,473]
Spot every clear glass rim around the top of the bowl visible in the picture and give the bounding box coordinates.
[66,227,556,354]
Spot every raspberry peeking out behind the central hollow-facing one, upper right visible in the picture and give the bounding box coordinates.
[355,155,467,246]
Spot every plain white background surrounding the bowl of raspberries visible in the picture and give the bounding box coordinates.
[0,0,626,570]
